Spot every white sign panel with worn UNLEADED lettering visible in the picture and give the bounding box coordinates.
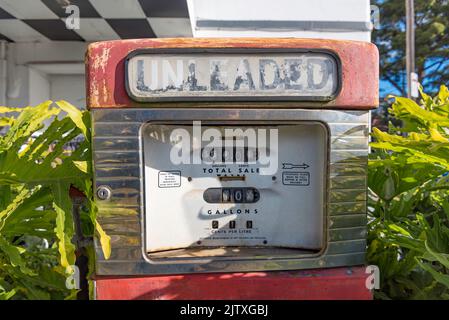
[126,52,339,101]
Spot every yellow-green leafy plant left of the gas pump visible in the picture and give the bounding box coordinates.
[0,101,110,299]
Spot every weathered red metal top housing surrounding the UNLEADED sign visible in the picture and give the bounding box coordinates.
[86,38,379,110]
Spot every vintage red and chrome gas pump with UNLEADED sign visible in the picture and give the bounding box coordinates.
[86,39,378,299]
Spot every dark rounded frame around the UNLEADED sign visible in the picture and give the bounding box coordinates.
[125,48,343,103]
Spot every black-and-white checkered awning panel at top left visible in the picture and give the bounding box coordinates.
[0,0,192,42]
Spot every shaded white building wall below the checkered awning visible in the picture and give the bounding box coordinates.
[0,42,87,109]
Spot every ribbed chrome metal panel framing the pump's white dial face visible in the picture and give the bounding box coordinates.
[92,105,369,275]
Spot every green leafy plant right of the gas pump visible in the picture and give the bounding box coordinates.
[367,86,449,299]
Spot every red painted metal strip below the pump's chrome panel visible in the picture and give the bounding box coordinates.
[96,267,372,300]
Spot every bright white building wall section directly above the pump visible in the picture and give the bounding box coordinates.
[187,0,371,41]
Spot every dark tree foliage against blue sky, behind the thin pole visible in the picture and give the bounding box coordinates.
[373,0,449,96]
